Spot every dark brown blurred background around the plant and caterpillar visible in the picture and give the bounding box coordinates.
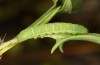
[0,0,100,65]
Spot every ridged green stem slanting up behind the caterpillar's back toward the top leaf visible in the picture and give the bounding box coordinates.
[29,6,61,27]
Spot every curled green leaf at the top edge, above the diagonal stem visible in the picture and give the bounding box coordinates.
[53,0,83,13]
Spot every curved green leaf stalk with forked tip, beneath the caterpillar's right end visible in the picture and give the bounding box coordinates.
[51,33,100,53]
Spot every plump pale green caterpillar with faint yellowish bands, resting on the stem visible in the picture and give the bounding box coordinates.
[17,23,88,42]
